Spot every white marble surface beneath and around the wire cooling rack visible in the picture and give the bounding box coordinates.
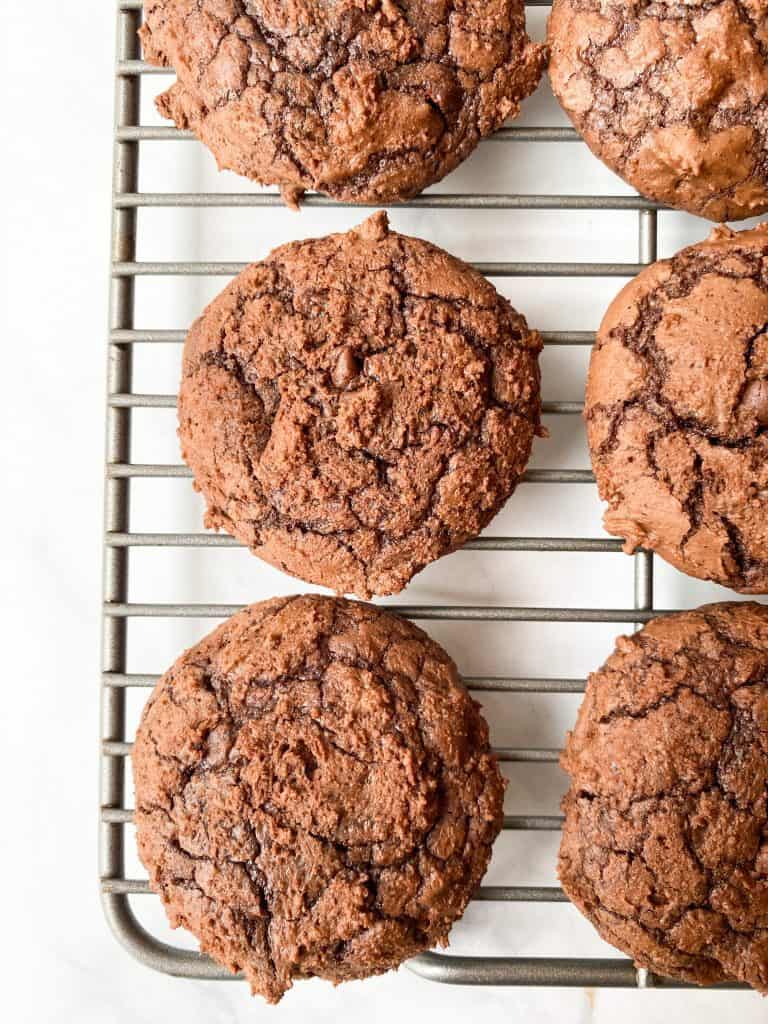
[0,6,767,1024]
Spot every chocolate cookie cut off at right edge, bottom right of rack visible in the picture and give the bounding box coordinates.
[559,603,768,992]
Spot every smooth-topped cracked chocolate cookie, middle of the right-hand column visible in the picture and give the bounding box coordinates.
[586,225,768,594]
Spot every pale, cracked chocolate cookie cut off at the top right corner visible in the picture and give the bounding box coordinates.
[549,0,768,220]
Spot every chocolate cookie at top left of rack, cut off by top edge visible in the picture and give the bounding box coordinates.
[141,0,546,205]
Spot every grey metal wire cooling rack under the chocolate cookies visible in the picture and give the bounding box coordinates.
[99,0,745,988]
